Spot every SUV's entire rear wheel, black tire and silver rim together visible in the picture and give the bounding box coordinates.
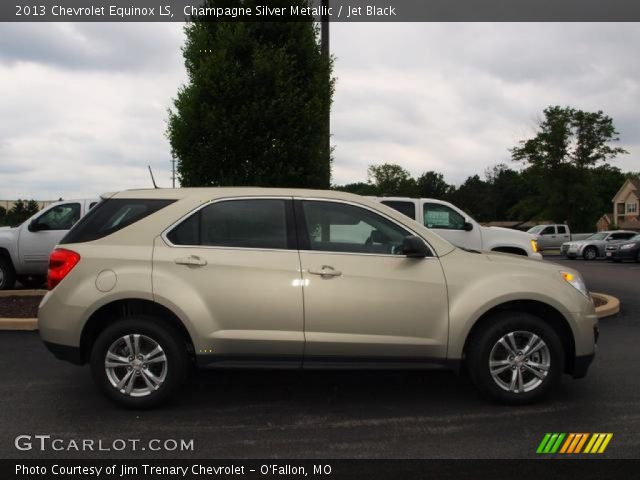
[91,316,189,408]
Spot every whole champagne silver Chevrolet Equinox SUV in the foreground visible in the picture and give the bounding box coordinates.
[39,188,598,407]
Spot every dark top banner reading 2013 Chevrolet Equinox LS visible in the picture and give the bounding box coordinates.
[0,0,640,22]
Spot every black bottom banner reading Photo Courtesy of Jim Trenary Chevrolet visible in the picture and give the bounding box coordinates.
[0,460,640,480]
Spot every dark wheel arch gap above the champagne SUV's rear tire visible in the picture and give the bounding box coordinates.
[80,298,194,362]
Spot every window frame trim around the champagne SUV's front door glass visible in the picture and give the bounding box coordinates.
[293,196,438,259]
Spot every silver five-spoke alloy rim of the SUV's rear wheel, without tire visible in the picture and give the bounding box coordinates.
[104,333,168,397]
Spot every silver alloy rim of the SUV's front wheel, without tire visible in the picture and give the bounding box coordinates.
[489,330,551,393]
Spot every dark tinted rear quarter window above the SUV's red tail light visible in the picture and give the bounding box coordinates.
[60,198,175,244]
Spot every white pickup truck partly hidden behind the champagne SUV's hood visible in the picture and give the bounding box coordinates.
[372,197,542,260]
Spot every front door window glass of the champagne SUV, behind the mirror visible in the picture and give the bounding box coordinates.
[302,200,411,255]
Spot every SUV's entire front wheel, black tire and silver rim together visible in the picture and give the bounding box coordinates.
[466,312,564,404]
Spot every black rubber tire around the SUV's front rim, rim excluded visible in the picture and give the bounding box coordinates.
[465,312,564,405]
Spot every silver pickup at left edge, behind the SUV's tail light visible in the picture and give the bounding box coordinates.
[0,199,98,290]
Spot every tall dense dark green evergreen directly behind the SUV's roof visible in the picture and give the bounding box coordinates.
[167,0,335,188]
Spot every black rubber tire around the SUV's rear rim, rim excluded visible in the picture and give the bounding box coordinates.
[90,315,190,409]
